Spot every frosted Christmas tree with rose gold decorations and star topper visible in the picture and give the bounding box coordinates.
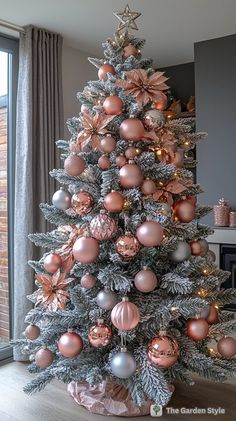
[14,6,236,414]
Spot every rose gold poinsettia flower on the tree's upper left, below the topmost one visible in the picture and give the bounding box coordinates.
[76,111,115,150]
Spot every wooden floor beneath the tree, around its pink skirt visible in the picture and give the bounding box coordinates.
[0,362,236,421]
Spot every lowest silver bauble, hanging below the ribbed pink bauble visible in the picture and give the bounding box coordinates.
[111,350,136,379]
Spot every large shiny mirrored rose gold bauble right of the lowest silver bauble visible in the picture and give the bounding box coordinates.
[148,335,179,368]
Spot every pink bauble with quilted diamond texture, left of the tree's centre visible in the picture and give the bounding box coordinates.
[89,211,117,241]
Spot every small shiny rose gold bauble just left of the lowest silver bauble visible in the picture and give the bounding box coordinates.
[88,319,112,348]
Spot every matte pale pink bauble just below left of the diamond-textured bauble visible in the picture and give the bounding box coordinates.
[73,237,99,264]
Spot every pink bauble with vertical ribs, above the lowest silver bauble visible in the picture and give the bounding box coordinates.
[111,297,140,330]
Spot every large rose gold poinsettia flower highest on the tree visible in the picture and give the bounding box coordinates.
[116,69,169,106]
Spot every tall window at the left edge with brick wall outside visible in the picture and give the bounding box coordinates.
[0,35,18,359]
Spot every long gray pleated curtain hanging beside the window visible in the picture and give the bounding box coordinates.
[13,26,63,360]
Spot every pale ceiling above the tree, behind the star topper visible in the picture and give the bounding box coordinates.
[0,0,236,67]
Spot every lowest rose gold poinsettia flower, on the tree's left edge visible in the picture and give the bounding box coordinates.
[35,269,74,311]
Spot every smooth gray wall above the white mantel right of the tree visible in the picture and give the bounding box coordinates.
[195,35,236,225]
